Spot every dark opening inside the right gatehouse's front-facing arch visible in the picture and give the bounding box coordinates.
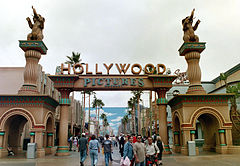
[195,113,220,152]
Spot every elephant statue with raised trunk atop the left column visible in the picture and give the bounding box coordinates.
[26,6,45,41]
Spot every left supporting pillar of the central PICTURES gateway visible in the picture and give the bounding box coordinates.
[56,89,71,156]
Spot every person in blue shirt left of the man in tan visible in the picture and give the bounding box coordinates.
[123,136,134,166]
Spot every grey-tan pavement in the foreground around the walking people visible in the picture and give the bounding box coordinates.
[0,147,240,166]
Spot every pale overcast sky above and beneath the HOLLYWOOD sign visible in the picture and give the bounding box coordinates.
[0,0,240,106]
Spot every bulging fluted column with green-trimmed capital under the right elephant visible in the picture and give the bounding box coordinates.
[178,43,206,94]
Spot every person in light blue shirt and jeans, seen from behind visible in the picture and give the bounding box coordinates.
[89,135,100,166]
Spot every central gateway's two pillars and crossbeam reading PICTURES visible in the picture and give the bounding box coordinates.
[48,74,176,156]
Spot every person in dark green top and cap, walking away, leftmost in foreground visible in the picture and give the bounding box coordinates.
[78,133,88,166]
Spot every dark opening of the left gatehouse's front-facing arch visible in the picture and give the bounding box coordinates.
[4,115,30,155]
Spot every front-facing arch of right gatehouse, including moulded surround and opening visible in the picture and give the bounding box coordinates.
[190,107,228,153]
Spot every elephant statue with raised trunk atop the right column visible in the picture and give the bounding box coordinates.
[182,9,200,42]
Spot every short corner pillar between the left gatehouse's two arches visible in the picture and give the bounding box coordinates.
[35,130,45,157]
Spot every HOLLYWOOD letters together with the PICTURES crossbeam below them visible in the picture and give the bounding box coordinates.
[49,63,176,91]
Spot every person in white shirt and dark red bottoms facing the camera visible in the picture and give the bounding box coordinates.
[146,137,159,166]
